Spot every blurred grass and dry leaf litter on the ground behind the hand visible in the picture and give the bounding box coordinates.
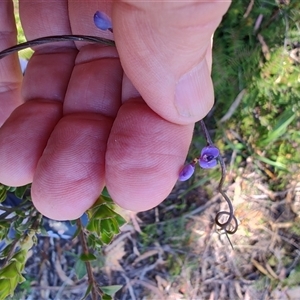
[0,0,300,300]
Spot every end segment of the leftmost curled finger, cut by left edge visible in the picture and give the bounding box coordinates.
[0,99,62,186]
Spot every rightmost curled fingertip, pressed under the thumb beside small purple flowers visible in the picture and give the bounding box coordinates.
[105,98,193,211]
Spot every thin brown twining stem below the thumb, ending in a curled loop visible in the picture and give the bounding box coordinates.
[200,120,238,241]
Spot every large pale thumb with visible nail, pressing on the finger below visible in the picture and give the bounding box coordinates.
[112,0,230,124]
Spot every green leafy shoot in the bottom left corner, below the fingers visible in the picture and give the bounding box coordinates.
[0,185,42,300]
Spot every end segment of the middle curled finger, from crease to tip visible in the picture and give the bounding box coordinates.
[31,113,112,220]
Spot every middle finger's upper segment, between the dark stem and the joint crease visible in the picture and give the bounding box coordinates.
[64,45,123,118]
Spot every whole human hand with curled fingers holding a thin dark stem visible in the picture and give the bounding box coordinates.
[0,0,229,220]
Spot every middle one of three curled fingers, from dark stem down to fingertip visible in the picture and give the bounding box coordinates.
[32,45,122,220]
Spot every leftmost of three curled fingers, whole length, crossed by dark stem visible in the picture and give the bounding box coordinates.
[0,0,77,186]
